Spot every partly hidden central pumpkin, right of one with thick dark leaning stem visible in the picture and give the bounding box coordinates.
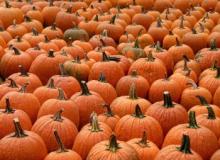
[87,73,117,104]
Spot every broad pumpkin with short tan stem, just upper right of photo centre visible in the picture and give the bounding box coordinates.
[128,52,166,84]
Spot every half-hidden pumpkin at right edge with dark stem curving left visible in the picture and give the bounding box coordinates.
[189,96,220,116]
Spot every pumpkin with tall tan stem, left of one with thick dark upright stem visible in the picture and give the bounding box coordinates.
[110,83,151,117]
